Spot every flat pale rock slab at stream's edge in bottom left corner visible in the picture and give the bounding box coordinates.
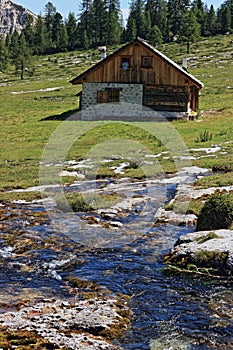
[0,297,126,350]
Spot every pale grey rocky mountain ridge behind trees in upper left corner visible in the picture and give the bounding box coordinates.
[0,0,37,36]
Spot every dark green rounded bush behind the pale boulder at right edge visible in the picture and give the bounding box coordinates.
[196,194,233,231]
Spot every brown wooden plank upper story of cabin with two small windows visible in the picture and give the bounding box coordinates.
[71,38,203,89]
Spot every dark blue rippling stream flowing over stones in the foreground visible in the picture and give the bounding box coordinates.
[0,172,233,350]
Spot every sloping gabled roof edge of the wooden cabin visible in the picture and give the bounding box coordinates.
[70,37,204,88]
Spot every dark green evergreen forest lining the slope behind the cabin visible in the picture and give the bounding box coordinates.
[0,0,233,79]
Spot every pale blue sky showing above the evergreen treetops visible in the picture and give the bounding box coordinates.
[15,0,224,18]
